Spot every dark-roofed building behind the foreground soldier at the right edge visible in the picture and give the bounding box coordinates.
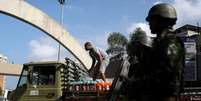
[175,24,201,81]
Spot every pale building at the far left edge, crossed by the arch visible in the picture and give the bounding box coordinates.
[0,54,8,90]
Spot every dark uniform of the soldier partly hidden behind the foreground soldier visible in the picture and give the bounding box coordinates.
[126,43,151,100]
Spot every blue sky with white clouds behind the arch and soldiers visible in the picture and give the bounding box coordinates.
[0,0,201,89]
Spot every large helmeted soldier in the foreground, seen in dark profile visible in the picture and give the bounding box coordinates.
[142,3,185,101]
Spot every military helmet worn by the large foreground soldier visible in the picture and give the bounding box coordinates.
[146,3,177,21]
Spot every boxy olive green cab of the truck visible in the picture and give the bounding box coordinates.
[9,61,66,101]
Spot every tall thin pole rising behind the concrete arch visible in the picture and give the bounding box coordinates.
[58,0,65,61]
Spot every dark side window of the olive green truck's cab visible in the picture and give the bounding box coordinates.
[32,66,56,85]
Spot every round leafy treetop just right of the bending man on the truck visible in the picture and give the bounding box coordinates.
[106,32,128,55]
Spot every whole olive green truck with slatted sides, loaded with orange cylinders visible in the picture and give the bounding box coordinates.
[8,58,129,101]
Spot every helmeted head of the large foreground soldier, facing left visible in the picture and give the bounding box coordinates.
[146,3,177,34]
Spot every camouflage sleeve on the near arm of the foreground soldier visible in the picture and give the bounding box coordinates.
[156,39,184,95]
